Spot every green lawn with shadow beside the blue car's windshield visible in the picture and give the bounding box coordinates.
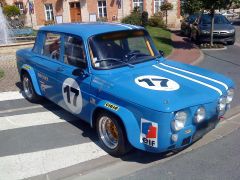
[147,26,173,56]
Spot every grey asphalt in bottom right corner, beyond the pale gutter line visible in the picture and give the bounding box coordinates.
[119,130,240,180]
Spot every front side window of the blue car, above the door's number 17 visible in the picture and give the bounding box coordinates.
[64,36,87,69]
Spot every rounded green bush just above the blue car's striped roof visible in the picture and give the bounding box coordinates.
[122,8,142,26]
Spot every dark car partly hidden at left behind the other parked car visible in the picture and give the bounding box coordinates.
[181,14,199,37]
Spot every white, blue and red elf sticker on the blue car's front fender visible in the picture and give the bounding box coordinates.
[140,119,158,148]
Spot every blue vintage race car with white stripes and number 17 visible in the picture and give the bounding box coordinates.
[17,23,234,156]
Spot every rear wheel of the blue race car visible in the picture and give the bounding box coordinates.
[21,73,40,102]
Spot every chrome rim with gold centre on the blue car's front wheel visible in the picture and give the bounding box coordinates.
[98,116,118,149]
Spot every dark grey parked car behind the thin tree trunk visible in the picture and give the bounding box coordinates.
[191,14,235,45]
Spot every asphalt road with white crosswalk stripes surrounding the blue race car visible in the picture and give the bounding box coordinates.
[0,46,240,180]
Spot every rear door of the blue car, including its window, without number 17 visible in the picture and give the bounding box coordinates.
[35,32,63,103]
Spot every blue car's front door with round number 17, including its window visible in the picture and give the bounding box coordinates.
[57,35,92,119]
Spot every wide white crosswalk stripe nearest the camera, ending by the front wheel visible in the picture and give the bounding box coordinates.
[0,142,107,179]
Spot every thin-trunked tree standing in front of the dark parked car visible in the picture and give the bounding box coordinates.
[201,0,232,46]
